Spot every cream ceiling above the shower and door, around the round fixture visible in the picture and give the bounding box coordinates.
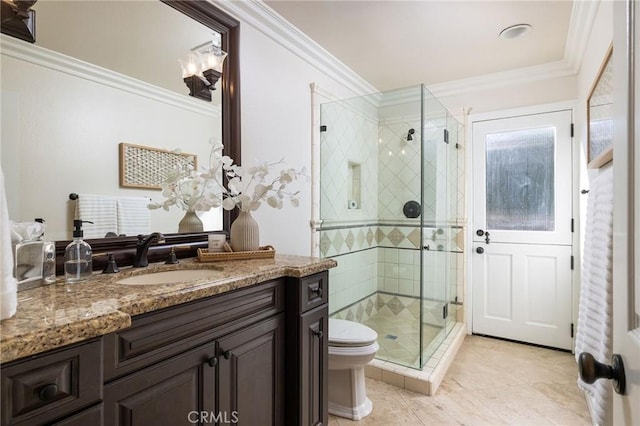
[265,0,573,90]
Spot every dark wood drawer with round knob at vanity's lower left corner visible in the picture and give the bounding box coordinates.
[2,340,102,425]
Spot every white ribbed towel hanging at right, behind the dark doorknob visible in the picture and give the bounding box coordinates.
[576,167,613,425]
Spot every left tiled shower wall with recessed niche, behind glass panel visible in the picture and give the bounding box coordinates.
[320,99,378,310]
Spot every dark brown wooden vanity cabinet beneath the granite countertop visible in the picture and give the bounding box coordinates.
[2,272,328,426]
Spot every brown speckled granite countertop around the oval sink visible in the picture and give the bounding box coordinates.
[0,254,336,363]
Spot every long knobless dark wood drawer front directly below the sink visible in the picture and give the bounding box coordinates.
[104,279,284,381]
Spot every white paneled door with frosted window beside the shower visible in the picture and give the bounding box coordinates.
[472,111,574,349]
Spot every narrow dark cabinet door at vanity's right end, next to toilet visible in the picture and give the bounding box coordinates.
[300,305,329,425]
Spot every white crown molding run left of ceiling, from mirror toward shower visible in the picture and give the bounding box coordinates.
[215,0,378,95]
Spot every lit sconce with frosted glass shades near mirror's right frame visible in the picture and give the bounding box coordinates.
[180,43,227,102]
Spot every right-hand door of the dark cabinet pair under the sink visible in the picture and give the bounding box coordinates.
[217,314,285,426]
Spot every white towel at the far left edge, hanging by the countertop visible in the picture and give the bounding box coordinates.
[0,168,18,320]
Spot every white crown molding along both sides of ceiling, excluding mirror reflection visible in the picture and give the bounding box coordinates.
[218,0,601,98]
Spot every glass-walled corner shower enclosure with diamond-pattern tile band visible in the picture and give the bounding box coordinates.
[317,86,464,369]
